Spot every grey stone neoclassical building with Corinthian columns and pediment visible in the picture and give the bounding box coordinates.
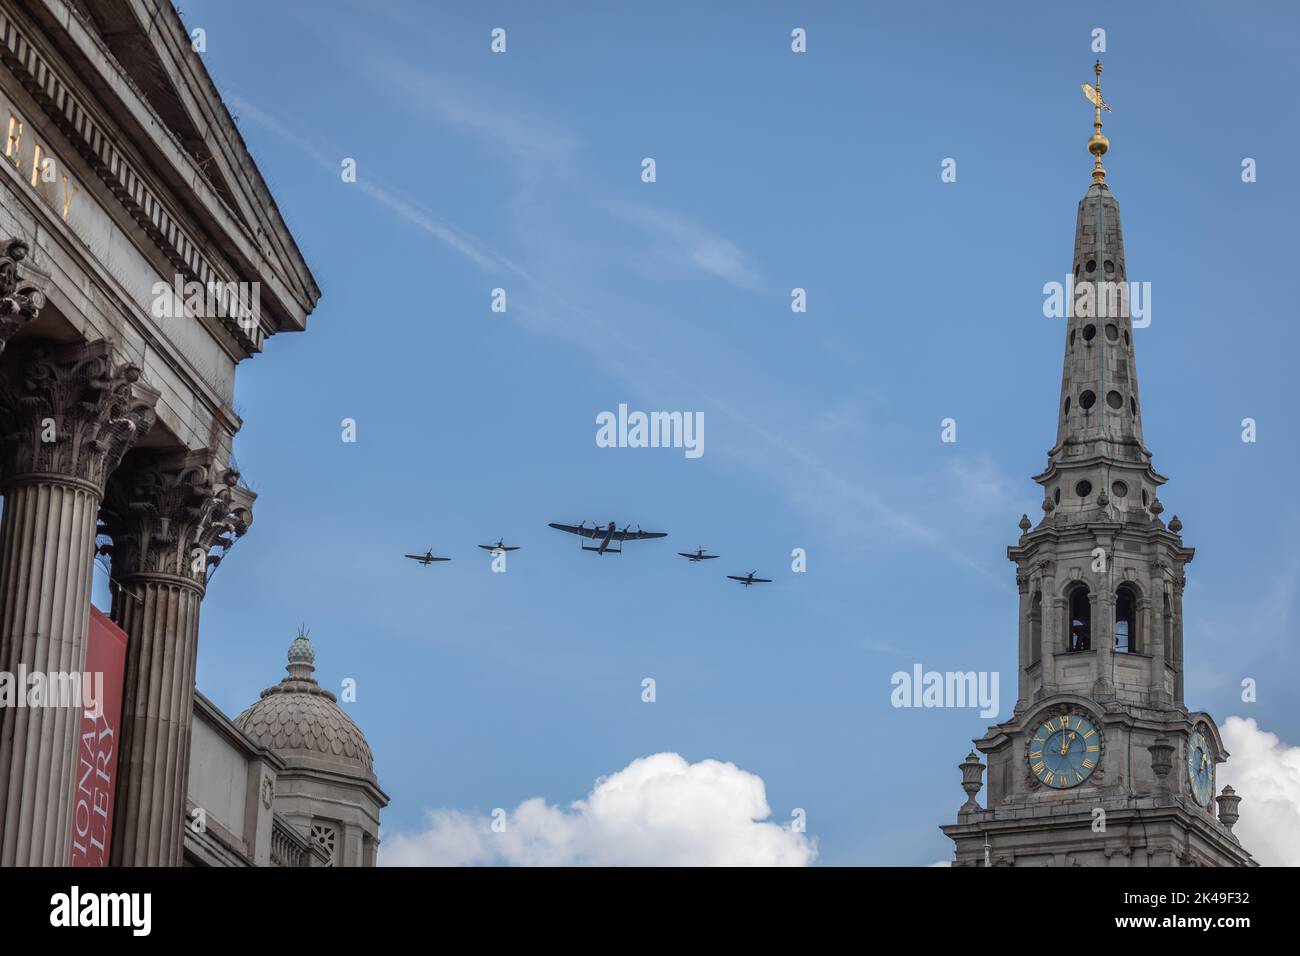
[0,0,386,866]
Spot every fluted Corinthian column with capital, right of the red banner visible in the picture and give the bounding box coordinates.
[101,450,254,866]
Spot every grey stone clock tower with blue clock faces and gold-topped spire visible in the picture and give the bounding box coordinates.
[943,62,1255,866]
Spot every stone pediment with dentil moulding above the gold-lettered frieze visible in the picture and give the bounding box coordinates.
[10,0,320,338]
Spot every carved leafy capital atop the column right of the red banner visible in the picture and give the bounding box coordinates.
[100,449,256,592]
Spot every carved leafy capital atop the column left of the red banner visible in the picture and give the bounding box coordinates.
[0,339,159,494]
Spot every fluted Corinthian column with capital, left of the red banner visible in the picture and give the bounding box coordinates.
[0,342,159,866]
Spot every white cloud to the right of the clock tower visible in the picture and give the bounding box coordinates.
[1218,717,1300,866]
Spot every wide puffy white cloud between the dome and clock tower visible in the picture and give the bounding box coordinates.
[380,753,816,866]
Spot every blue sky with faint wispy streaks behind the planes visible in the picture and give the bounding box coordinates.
[159,0,1300,865]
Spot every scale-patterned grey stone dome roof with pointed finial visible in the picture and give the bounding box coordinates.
[235,632,374,779]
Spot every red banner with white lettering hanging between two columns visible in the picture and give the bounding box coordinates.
[72,605,126,866]
